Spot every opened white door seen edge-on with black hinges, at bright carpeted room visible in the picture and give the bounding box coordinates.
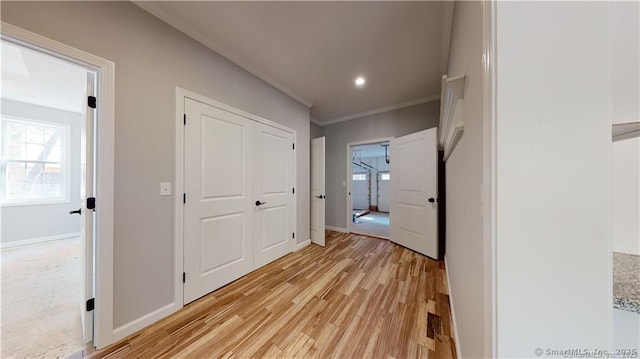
[79,72,96,343]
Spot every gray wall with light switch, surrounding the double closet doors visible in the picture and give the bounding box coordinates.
[1,1,309,327]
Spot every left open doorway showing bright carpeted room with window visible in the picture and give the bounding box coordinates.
[0,40,96,357]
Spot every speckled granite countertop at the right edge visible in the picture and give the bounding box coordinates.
[613,252,640,314]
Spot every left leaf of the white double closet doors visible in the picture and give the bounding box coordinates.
[184,98,255,304]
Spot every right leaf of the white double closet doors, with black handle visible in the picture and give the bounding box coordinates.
[253,123,295,268]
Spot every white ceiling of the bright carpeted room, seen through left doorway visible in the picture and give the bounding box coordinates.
[0,41,87,112]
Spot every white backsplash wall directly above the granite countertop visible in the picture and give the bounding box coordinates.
[611,137,640,255]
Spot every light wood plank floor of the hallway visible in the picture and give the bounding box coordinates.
[84,232,456,358]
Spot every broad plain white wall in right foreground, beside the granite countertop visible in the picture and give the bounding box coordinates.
[496,2,612,358]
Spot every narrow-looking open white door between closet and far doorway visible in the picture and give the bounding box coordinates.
[311,137,325,247]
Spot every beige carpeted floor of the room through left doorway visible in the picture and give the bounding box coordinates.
[0,237,84,358]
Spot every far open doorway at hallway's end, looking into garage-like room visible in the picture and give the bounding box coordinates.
[349,140,391,239]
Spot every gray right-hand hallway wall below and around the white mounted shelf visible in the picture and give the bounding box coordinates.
[444,1,486,358]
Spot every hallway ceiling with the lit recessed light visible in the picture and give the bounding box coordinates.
[136,1,453,124]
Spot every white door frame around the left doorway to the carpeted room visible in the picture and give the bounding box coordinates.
[1,22,119,348]
